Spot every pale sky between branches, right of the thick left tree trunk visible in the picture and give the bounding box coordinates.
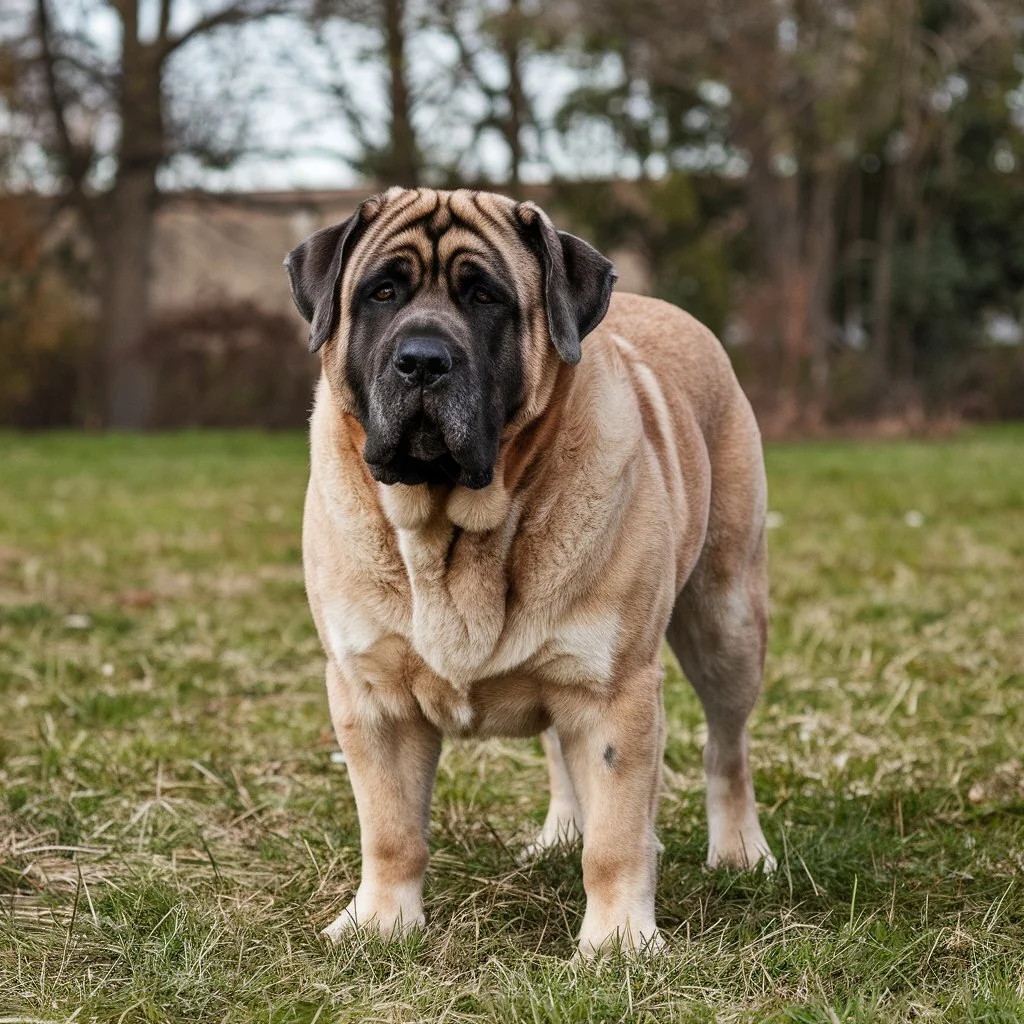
[149,3,622,190]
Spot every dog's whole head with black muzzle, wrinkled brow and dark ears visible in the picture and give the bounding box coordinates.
[285,188,614,488]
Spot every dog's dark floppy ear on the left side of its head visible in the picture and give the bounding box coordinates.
[285,210,361,352]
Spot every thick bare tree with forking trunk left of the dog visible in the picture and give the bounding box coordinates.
[19,0,295,429]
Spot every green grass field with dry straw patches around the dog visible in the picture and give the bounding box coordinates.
[0,428,1024,1024]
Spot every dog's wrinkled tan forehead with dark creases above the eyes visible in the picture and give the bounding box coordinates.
[345,188,527,298]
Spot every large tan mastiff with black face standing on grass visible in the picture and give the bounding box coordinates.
[285,188,774,956]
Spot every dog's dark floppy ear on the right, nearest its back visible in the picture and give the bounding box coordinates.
[516,202,617,366]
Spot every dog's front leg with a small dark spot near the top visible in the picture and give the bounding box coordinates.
[555,664,665,956]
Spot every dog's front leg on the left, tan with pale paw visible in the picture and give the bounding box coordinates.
[323,664,441,942]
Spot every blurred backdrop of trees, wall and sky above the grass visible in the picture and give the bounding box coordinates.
[0,0,1024,435]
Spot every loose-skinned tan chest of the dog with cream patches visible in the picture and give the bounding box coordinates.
[324,468,626,735]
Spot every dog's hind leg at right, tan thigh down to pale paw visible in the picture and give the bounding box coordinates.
[666,450,775,870]
